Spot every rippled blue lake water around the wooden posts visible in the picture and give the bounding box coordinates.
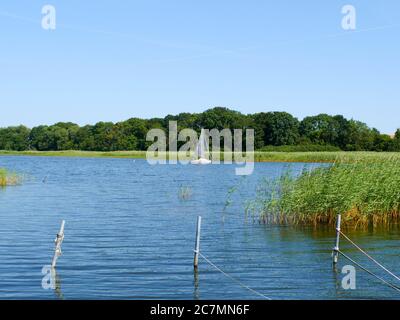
[0,156,400,299]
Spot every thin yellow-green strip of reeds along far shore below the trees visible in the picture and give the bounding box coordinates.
[0,150,400,163]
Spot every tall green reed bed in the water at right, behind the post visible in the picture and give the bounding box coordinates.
[246,154,400,228]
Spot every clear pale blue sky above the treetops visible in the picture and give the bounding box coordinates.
[0,0,400,133]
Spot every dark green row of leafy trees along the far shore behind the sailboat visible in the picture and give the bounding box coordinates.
[0,107,400,151]
